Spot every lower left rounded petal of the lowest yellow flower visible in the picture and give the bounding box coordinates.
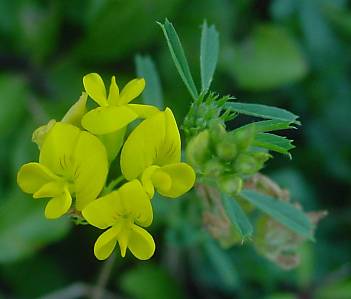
[94,225,120,260]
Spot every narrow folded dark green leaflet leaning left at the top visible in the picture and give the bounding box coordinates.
[157,19,198,100]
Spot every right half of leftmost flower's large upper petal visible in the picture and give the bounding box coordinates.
[72,131,108,211]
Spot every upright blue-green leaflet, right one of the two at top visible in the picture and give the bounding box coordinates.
[200,21,219,92]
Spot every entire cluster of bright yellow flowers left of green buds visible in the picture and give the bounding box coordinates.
[17,73,195,260]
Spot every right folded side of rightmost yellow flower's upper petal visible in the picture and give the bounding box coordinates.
[155,108,181,166]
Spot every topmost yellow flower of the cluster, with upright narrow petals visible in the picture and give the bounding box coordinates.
[82,73,158,135]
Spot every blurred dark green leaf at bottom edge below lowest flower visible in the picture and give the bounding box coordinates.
[119,263,185,299]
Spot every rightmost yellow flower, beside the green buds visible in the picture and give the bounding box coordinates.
[121,108,195,198]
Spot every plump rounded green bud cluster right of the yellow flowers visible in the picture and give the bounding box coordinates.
[186,121,271,194]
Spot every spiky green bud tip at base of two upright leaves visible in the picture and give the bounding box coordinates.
[182,92,236,140]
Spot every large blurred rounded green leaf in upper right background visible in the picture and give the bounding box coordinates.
[224,24,307,90]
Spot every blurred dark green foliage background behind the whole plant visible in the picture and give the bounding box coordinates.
[0,0,351,299]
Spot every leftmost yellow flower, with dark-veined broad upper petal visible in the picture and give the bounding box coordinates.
[17,122,108,219]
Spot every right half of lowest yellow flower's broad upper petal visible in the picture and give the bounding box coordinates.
[117,180,153,226]
